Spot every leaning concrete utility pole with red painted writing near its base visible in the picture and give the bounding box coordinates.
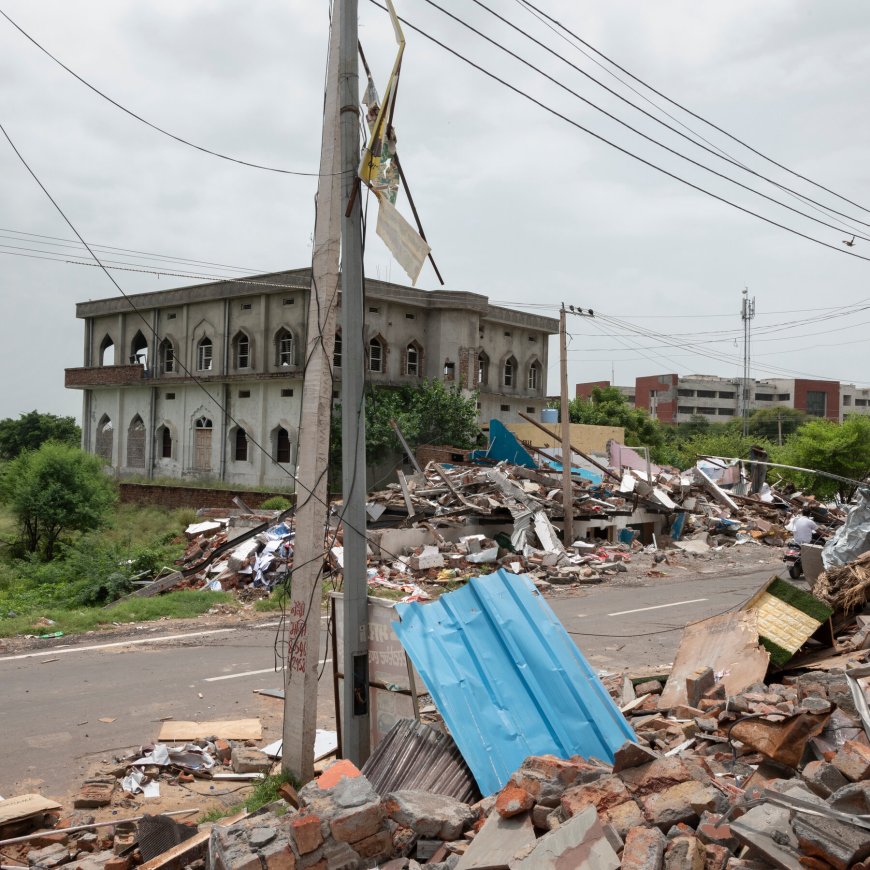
[281,3,342,782]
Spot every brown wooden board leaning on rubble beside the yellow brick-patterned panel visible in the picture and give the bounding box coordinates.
[658,610,770,710]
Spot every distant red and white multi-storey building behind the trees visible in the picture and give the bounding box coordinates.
[576,374,870,423]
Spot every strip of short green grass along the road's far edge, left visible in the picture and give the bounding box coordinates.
[0,590,236,637]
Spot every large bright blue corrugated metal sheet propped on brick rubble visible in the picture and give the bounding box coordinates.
[394,569,634,794]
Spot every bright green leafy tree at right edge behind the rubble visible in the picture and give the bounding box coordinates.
[774,416,870,498]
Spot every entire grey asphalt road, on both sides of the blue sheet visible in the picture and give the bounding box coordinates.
[0,567,771,797]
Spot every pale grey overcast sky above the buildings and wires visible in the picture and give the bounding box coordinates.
[0,0,870,417]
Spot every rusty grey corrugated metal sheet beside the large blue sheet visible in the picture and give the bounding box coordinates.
[362,719,480,803]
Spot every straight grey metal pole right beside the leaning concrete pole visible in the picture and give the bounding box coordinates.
[337,0,370,766]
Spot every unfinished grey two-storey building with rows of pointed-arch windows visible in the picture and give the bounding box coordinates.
[66,269,558,489]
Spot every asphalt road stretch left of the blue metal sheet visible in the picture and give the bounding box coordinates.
[0,620,332,797]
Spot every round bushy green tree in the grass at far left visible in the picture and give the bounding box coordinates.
[0,441,117,561]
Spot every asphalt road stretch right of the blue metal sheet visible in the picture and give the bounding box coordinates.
[550,566,778,673]
